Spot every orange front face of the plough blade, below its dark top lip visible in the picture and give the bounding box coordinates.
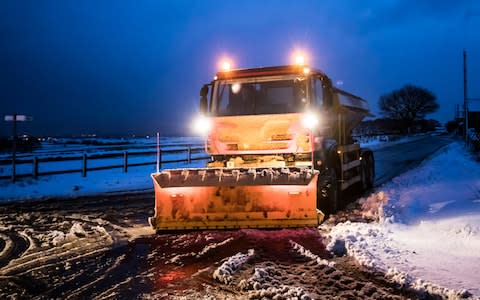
[152,174,318,230]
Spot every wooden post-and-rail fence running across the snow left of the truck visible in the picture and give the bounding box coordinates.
[0,145,210,181]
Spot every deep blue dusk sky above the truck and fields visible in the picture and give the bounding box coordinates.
[0,0,480,135]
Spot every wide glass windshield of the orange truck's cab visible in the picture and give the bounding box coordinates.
[211,77,307,116]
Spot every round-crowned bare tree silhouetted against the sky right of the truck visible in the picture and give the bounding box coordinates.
[379,84,439,129]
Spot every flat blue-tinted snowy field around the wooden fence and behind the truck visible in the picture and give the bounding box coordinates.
[0,136,422,202]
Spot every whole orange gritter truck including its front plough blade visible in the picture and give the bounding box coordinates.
[149,64,375,232]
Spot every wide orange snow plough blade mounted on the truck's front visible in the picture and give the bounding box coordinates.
[149,168,323,231]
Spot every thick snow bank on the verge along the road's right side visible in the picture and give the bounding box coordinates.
[327,143,480,299]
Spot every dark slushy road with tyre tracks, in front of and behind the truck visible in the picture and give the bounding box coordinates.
[0,137,456,299]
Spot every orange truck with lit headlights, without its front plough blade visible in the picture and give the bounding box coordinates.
[197,65,374,211]
